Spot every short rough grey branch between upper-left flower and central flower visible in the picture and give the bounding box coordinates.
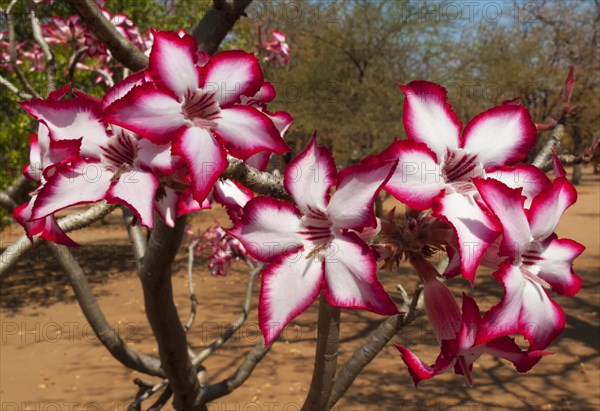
[221,159,292,201]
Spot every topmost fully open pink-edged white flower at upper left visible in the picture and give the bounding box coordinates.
[105,32,288,202]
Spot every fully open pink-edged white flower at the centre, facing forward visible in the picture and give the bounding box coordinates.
[230,136,398,344]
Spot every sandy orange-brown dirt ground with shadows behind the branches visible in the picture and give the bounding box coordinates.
[0,168,600,411]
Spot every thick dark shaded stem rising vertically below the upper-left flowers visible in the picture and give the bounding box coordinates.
[139,217,202,410]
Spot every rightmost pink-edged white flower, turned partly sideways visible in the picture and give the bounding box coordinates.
[474,177,585,350]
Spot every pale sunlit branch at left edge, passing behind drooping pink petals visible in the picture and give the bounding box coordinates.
[0,203,116,275]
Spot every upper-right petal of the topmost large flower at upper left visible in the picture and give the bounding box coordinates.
[202,50,264,107]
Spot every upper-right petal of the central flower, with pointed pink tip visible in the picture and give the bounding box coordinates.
[327,161,396,231]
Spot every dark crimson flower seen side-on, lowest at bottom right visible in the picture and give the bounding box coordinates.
[396,294,549,387]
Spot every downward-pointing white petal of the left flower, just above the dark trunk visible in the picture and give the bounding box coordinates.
[106,170,159,229]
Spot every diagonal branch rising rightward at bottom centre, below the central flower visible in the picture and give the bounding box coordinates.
[326,284,423,410]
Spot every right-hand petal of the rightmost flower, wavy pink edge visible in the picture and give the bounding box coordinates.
[536,238,585,295]
